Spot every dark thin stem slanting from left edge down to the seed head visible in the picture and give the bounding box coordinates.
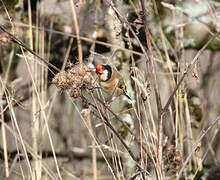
[0,25,60,72]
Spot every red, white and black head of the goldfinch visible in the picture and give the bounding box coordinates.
[96,64,112,81]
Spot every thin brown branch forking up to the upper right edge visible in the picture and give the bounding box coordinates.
[161,32,220,114]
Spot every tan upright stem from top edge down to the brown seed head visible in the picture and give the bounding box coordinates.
[70,0,83,64]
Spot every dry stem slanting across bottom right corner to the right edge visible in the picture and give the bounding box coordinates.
[176,116,220,180]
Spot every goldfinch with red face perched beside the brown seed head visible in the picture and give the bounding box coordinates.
[96,64,131,101]
